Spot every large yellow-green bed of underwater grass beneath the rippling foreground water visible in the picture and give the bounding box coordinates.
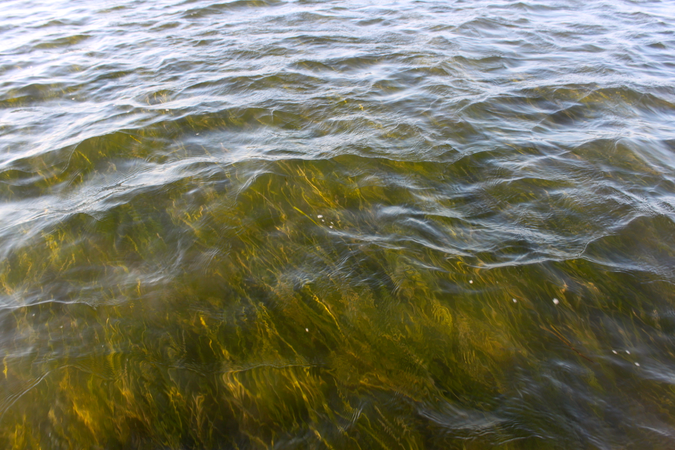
[0,133,675,449]
